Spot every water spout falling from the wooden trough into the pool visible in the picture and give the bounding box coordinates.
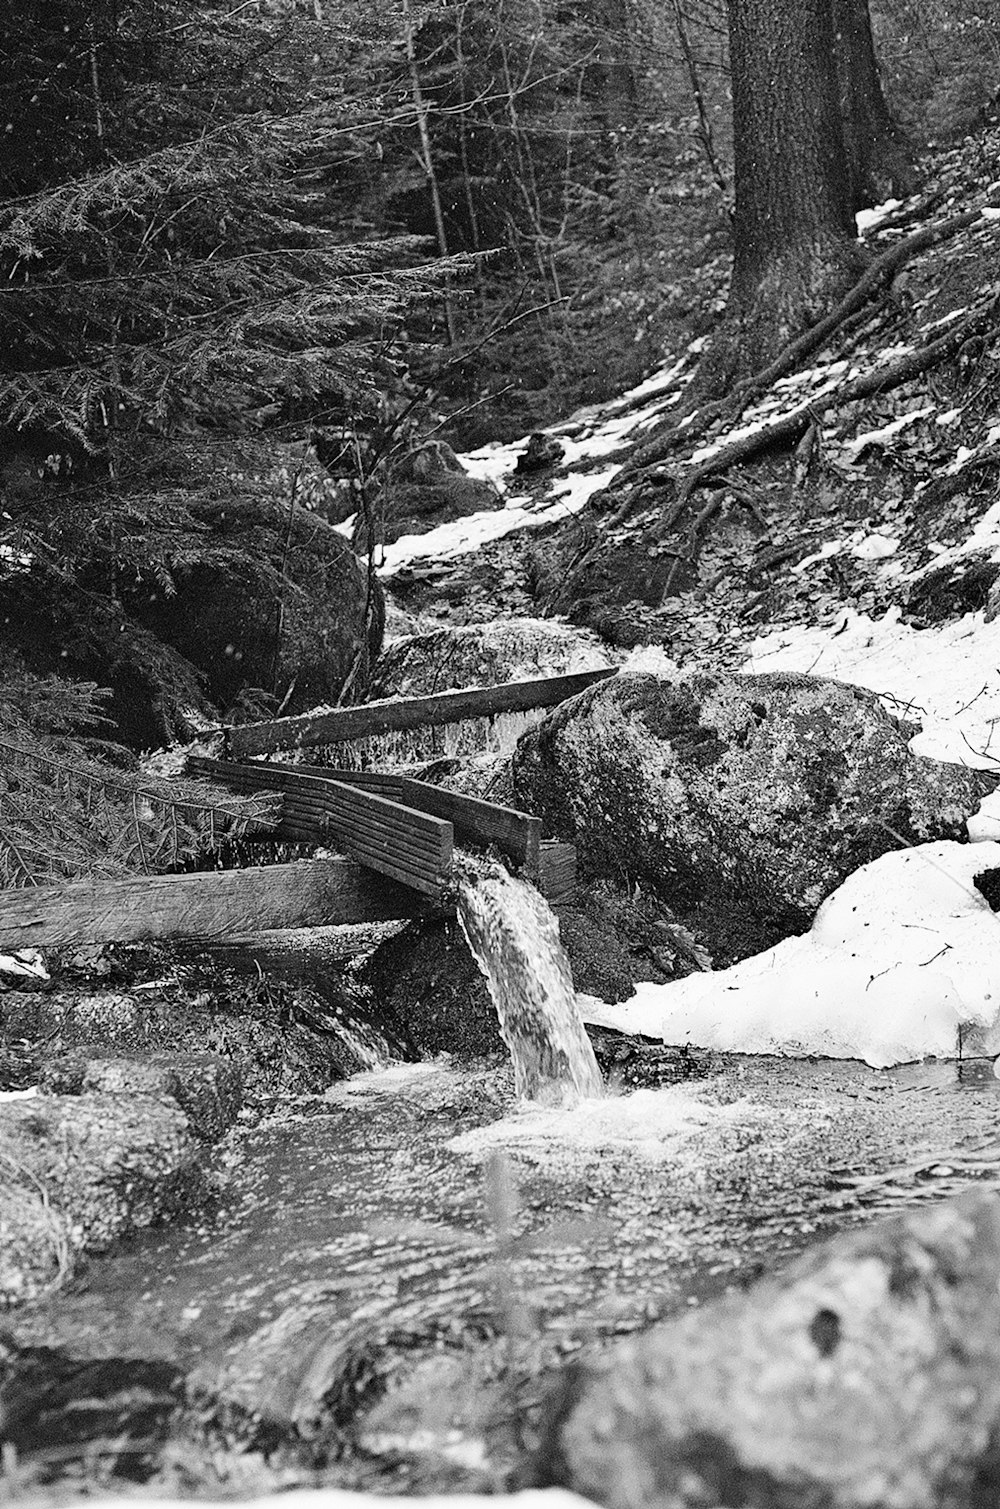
[454,854,603,1106]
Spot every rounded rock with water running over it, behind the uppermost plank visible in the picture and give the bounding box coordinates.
[374,619,611,697]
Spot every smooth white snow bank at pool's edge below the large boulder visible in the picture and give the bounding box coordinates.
[582,842,1000,1068]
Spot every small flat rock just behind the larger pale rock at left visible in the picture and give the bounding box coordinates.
[39,1053,243,1142]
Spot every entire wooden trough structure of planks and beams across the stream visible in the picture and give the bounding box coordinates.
[0,670,594,949]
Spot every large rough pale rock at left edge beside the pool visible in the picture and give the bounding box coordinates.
[0,1094,204,1305]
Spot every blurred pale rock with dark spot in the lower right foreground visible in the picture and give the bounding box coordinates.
[538,1191,1000,1509]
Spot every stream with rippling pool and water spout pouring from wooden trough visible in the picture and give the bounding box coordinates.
[0,863,1000,1492]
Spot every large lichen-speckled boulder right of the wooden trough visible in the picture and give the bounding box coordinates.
[513,673,997,966]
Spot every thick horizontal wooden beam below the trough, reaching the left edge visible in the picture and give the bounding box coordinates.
[0,859,437,949]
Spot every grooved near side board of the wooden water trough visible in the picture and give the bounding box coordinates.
[189,756,454,896]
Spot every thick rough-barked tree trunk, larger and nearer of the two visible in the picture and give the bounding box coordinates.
[729,0,857,376]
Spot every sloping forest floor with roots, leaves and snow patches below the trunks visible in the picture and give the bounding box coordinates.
[382,130,1000,712]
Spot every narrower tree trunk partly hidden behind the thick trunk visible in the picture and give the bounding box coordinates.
[833,0,917,210]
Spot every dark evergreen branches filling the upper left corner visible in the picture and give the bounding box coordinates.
[0,0,461,742]
